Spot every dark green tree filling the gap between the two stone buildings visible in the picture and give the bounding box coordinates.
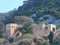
[16,24,33,34]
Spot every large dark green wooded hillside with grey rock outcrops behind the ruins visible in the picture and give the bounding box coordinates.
[0,0,60,24]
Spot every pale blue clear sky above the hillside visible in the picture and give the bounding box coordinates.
[0,0,24,13]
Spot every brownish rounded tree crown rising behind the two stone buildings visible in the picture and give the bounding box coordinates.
[15,16,34,24]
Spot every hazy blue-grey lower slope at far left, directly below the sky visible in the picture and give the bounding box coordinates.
[0,9,16,23]
